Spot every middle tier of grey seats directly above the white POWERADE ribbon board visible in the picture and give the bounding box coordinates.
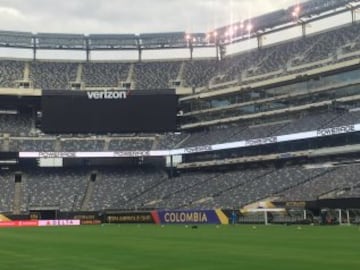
[0,110,360,152]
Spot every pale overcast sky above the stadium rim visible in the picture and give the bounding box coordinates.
[0,0,304,34]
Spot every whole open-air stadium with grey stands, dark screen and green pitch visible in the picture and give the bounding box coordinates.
[0,0,360,269]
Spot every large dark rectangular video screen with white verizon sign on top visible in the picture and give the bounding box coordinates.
[41,89,178,133]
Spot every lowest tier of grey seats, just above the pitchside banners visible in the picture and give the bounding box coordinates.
[4,164,360,211]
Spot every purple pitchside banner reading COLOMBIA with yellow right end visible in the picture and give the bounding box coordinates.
[153,210,228,224]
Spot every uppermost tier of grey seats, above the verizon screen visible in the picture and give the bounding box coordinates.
[0,23,360,89]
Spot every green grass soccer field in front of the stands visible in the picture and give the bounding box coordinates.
[0,225,360,270]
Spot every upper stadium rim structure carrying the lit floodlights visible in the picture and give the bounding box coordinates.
[0,0,360,50]
